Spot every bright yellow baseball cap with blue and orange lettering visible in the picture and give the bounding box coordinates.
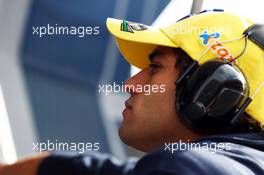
[106,12,264,125]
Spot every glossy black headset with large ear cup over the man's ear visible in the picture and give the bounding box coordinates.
[175,10,264,134]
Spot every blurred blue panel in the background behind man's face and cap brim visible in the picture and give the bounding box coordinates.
[20,0,169,156]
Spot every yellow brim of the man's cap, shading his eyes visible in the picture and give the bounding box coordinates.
[106,18,177,69]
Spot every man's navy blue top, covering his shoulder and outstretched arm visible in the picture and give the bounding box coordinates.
[38,133,264,175]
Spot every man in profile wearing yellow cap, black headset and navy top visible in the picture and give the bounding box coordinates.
[0,11,264,175]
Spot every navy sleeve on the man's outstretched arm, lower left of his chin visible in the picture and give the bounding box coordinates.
[38,153,137,175]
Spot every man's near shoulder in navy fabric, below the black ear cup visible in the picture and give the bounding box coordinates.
[135,133,264,175]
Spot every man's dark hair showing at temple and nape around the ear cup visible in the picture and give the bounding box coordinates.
[173,48,264,133]
